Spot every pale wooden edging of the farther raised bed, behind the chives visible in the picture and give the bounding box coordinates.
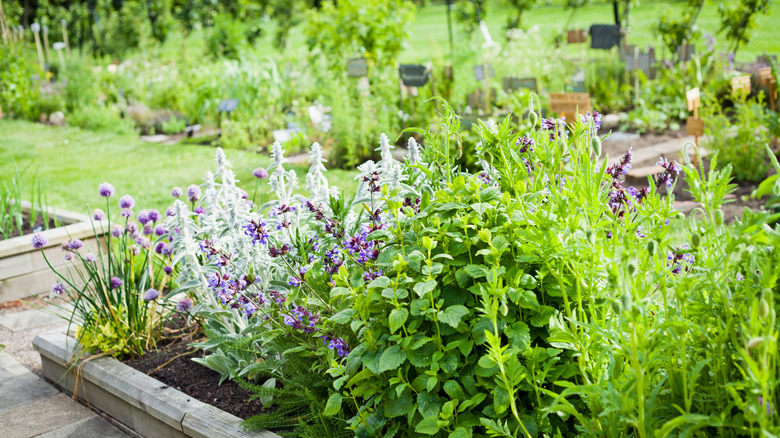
[0,201,108,303]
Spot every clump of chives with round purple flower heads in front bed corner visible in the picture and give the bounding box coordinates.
[32,183,181,357]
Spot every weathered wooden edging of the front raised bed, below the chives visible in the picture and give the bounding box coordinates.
[33,331,279,438]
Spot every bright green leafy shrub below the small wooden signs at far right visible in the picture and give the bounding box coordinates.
[700,98,770,182]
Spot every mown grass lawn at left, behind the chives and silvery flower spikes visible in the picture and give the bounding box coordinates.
[0,120,356,216]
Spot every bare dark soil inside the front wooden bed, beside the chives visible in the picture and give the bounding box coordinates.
[125,322,266,419]
